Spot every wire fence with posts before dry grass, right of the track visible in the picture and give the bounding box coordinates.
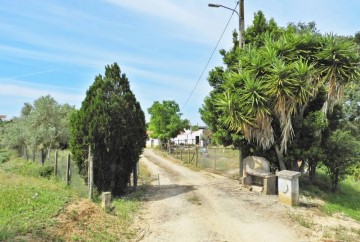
[166,143,240,178]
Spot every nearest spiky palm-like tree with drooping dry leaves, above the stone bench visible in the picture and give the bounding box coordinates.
[217,30,315,169]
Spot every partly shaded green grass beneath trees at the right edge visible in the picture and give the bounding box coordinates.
[302,168,360,221]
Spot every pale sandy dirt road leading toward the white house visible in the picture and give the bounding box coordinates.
[137,149,309,242]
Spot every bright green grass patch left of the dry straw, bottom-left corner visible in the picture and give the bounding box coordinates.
[0,164,76,240]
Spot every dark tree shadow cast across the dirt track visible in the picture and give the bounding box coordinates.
[144,184,196,201]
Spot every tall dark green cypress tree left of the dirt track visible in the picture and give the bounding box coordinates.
[70,63,146,195]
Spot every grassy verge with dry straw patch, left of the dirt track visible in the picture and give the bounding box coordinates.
[0,153,150,241]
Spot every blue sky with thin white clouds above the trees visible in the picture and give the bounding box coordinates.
[0,0,360,124]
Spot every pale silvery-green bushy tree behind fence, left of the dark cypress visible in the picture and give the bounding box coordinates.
[3,95,74,156]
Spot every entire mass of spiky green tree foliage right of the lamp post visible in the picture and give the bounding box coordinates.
[200,12,360,179]
